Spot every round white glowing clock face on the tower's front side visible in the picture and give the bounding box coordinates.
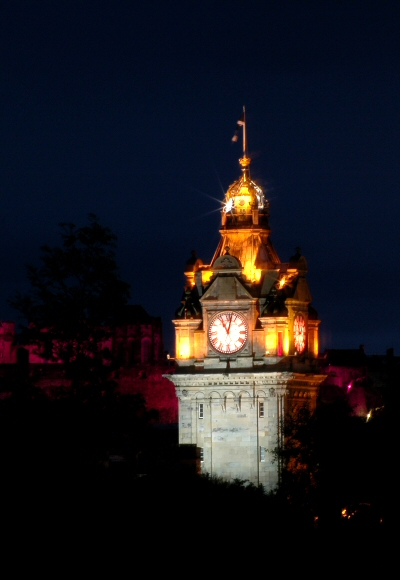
[208,310,248,354]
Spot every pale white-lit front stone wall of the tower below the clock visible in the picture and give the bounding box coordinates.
[167,372,293,490]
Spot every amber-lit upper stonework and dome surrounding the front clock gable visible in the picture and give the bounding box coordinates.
[175,144,319,366]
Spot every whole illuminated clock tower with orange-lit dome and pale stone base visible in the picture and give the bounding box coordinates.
[167,114,325,490]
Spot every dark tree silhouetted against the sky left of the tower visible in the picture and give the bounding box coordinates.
[9,214,129,384]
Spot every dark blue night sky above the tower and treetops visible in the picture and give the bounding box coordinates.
[0,0,400,354]
